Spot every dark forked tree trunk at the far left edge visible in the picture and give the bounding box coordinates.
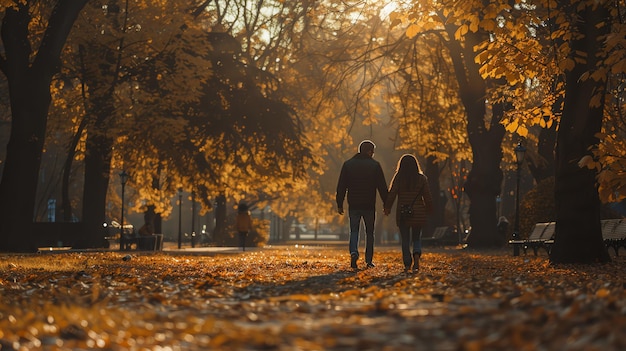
[0,0,86,251]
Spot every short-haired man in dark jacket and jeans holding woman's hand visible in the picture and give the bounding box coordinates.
[336,140,387,269]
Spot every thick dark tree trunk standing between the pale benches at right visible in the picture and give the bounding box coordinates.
[550,1,611,263]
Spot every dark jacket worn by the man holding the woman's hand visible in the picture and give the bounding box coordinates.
[336,153,387,210]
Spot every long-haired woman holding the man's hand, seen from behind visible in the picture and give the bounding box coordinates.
[384,154,433,272]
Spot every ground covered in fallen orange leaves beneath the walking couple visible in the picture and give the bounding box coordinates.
[0,245,626,350]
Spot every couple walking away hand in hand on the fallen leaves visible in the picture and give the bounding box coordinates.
[336,140,432,272]
